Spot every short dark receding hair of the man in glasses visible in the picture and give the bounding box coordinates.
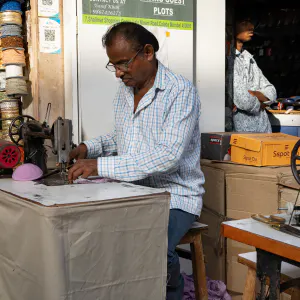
[102,22,159,52]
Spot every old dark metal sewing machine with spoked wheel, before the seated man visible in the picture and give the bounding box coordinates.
[9,115,74,180]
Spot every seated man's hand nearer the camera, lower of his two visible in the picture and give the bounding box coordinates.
[68,159,98,183]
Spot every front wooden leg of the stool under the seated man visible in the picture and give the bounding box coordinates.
[190,234,208,300]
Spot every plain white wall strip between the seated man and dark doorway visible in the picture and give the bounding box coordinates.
[196,0,226,132]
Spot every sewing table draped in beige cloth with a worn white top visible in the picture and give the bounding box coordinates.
[0,179,170,300]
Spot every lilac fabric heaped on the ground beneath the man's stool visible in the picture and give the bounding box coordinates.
[182,273,231,300]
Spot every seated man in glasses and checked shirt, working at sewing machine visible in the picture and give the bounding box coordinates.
[68,22,204,300]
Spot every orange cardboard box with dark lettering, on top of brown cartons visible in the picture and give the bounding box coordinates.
[230,133,299,166]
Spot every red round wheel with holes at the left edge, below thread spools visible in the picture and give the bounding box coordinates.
[0,140,21,169]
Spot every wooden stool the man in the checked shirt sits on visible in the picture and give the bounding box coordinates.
[176,222,208,300]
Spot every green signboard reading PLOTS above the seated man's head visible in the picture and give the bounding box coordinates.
[82,0,194,30]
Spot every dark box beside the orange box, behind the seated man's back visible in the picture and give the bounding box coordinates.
[201,132,232,160]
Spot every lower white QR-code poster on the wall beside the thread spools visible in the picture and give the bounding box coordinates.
[39,18,61,54]
